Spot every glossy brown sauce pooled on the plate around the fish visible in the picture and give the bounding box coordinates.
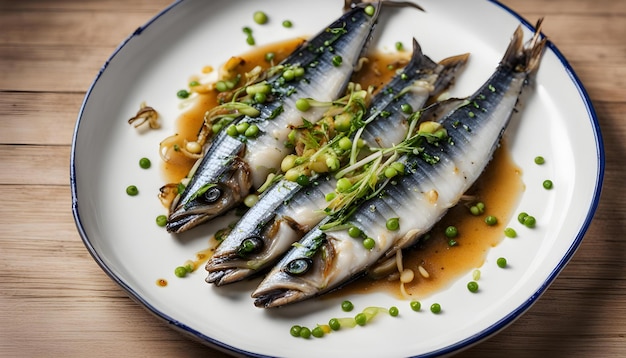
[162,39,524,298]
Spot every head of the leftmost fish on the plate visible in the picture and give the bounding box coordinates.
[166,157,252,233]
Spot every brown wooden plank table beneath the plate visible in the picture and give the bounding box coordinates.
[0,0,626,357]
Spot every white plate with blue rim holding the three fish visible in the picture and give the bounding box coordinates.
[71,0,604,357]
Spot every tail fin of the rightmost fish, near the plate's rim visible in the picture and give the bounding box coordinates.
[500,18,548,73]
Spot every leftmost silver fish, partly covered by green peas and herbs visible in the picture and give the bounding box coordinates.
[166,2,381,233]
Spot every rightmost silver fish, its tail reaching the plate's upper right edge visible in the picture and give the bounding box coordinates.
[252,21,546,308]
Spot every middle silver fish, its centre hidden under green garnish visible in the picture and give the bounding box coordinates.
[205,40,468,285]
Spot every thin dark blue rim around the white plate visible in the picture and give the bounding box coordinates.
[70,0,605,357]
